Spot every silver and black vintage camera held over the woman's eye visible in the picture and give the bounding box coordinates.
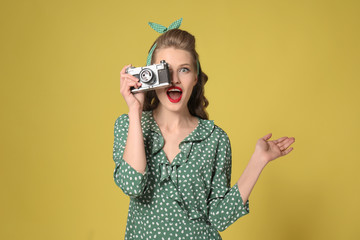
[126,60,171,93]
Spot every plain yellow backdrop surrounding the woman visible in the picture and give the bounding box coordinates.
[0,0,360,240]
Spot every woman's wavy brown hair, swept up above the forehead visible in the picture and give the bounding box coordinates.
[143,29,209,119]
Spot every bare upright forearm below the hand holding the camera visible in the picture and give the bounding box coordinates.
[123,110,146,173]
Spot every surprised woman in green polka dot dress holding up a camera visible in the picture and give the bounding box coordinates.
[113,18,295,240]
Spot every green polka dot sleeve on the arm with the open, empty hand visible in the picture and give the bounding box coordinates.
[208,130,249,231]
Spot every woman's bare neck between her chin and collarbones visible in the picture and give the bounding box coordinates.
[153,105,198,131]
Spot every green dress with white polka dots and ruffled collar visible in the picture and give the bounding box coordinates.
[113,111,249,240]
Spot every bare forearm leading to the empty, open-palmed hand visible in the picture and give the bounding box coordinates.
[237,155,266,205]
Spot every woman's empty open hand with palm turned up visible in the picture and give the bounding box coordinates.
[253,133,295,164]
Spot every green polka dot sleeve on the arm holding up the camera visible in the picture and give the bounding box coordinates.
[113,114,148,197]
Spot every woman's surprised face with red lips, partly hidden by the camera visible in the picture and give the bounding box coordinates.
[155,48,197,111]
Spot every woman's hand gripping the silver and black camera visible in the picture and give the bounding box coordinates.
[120,64,145,112]
